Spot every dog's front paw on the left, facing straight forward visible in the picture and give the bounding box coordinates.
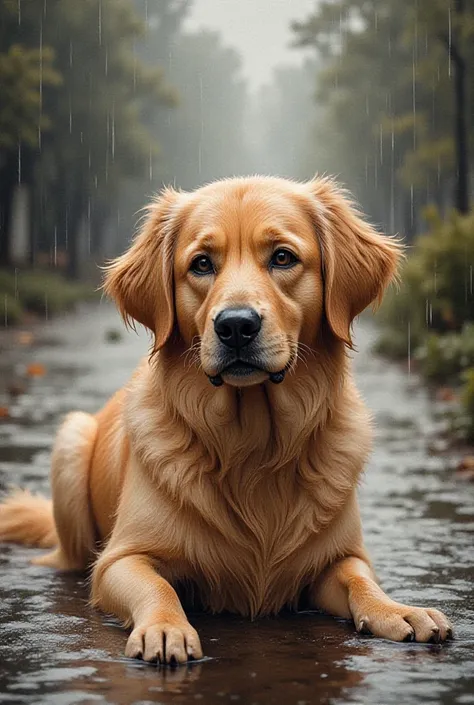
[125,620,203,664]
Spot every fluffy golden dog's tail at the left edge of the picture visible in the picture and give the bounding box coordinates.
[0,490,58,548]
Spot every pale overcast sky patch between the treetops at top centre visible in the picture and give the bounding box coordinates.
[186,0,316,89]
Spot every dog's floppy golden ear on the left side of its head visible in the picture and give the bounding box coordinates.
[103,188,183,350]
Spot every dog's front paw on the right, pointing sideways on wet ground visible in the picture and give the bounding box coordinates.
[354,601,453,644]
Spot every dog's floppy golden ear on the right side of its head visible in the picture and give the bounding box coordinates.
[307,178,403,347]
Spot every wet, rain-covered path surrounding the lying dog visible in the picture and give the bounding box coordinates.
[0,305,474,705]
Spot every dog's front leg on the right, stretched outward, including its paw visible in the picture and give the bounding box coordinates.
[311,556,452,642]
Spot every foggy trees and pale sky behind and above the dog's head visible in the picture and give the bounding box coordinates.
[0,0,474,284]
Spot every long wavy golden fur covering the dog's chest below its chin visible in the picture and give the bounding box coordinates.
[128,364,370,615]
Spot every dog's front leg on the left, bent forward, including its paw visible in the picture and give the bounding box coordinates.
[92,552,202,663]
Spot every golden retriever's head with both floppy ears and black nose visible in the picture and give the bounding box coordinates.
[105,177,401,387]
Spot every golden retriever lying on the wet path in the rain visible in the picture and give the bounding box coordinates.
[0,177,452,664]
